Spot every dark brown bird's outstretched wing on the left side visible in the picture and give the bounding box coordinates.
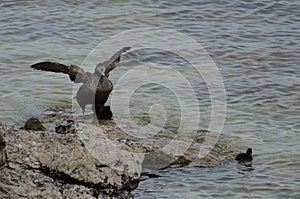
[31,62,91,83]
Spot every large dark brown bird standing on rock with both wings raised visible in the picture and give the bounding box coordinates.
[31,47,130,115]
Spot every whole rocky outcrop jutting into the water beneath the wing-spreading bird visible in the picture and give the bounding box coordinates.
[0,109,232,199]
